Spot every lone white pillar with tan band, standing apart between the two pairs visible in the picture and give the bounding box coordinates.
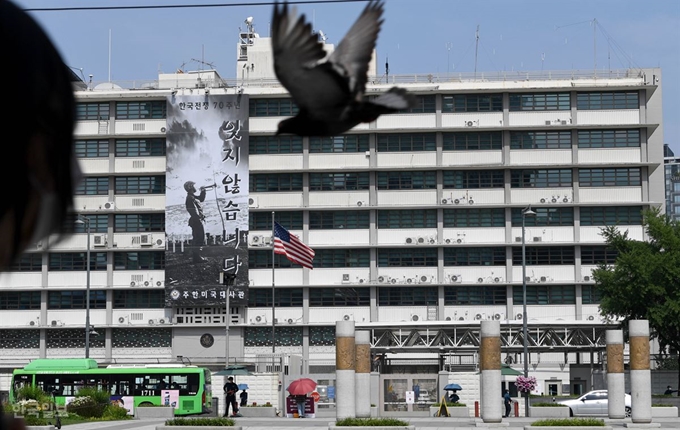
[479,321,503,423]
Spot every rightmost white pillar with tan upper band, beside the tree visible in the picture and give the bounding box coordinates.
[628,320,652,424]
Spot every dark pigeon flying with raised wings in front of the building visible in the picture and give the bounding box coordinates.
[272,0,415,136]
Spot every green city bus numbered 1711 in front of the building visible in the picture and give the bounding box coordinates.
[10,358,212,415]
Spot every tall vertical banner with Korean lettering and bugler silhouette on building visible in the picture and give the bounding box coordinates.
[165,95,249,306]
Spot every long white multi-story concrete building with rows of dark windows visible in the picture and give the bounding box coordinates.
[0,25,677,408]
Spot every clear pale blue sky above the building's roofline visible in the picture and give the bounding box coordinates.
[14,0,680,155]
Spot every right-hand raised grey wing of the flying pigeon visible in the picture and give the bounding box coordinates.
[328,0,383,101]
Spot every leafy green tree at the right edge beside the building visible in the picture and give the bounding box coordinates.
[593,209,680,395]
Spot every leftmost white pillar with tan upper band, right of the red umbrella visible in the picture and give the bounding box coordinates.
[335,321,356,420]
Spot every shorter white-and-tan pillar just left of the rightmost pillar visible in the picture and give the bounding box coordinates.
[607,330,626,419]
